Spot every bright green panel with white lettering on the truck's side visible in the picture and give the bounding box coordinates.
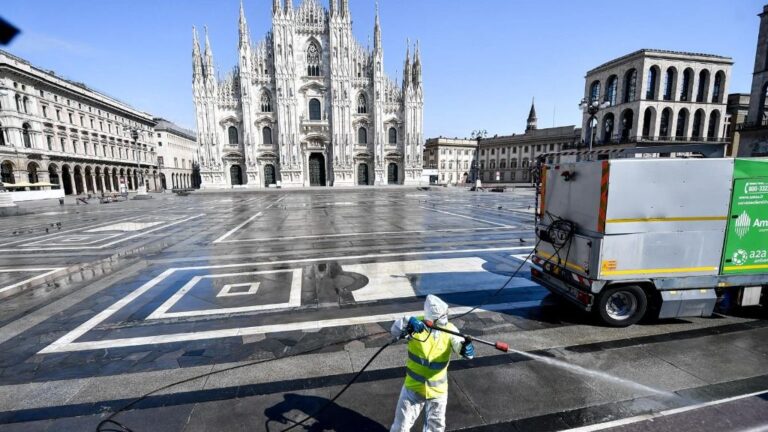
[720,159,768,275]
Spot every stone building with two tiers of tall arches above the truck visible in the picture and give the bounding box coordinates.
[582,49,733,147]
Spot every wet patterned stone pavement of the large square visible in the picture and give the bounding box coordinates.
[0,188,768,432]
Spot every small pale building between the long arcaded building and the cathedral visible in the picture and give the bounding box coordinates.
[154,117,200,189]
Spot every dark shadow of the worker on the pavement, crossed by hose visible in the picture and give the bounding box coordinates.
[264,393,387,432]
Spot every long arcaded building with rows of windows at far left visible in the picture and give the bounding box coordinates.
[0,51,159,195]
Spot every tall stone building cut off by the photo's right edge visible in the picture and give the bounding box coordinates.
[734,5,768,157]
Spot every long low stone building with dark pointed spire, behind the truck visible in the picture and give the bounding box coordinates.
[478,103,581,183]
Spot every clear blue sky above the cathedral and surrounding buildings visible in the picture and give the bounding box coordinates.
[0,0,763,137]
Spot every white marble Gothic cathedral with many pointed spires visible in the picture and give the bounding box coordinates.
[192,0,424,188]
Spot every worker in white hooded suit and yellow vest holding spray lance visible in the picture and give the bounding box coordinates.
[390,294,475,432]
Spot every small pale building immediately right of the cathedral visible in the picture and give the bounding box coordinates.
[424,137,477,184]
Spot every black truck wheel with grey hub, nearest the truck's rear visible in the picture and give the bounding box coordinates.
[597,285,648,327]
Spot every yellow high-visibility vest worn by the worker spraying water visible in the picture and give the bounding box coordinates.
[405,318,458,399]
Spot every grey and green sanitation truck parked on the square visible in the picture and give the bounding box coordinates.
[531,158,768,327]
